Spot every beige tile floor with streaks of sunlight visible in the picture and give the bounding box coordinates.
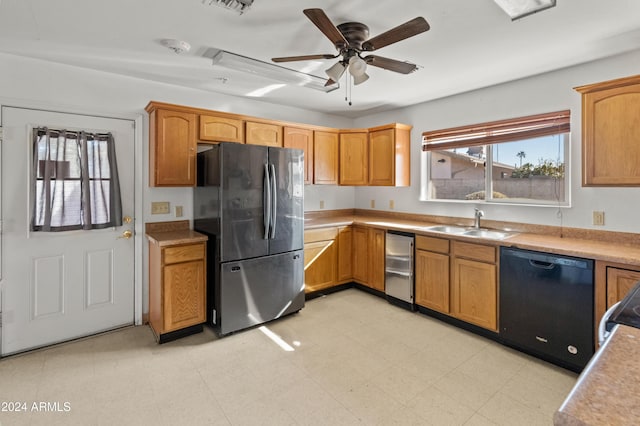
[0,289,577,426]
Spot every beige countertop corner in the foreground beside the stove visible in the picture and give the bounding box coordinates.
[553,325,640,426]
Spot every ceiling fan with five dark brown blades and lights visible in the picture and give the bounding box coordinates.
[271,9,429,85]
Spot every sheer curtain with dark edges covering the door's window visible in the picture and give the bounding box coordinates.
[32,127,122,232]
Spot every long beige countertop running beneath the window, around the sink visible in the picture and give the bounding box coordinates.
[305,214,640,266]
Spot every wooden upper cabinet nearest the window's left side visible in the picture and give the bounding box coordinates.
[369,124,411,186]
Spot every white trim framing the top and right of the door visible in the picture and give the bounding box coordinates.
[0,97,145,353]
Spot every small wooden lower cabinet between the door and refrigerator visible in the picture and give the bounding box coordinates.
[149,242,207,343]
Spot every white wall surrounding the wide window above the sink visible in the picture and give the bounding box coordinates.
[355,50,640,232]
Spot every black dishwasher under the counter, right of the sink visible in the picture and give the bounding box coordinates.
[500,247,594,371]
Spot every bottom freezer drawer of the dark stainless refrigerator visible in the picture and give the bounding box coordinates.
[217,250,304,335]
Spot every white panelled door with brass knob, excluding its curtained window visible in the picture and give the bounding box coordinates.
[0,107,135,355]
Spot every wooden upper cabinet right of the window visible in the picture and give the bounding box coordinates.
[576,75,640,186]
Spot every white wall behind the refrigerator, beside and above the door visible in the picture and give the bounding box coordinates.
[0,54,354,312]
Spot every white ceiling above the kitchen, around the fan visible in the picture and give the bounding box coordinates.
[0,0,640,117]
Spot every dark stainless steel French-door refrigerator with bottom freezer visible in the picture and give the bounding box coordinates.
[193,142,304,335]
